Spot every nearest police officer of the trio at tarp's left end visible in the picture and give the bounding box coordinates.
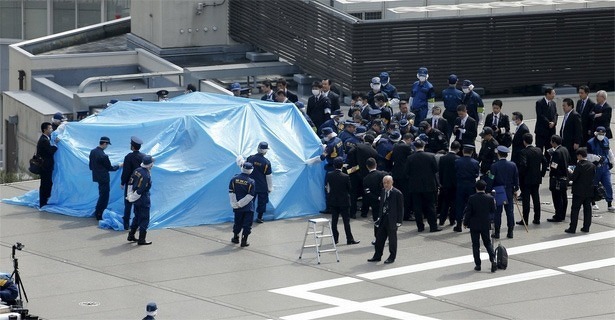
[128,155,154,245]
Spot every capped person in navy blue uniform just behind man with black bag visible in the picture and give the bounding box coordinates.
[491,146,519,239]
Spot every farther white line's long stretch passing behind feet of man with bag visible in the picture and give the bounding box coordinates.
[357,230,615,280]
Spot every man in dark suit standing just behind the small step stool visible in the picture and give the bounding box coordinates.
[325,157,360,245]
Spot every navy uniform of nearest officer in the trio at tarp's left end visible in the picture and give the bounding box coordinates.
[128,167,152,232]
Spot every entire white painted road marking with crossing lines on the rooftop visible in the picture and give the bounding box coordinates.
[270,230,615,320]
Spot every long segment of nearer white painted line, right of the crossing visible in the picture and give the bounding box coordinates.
[421,269,564,297]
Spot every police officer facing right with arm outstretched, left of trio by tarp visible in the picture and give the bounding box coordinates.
[90,137,123,220]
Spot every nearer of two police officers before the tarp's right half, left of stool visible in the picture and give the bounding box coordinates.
[228,162,256,247]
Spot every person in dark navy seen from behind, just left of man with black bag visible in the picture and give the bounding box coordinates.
[453,145,480,232]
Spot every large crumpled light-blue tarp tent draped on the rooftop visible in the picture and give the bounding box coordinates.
[3,92,325,230]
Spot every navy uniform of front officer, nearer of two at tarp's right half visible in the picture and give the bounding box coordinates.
[228,173,256,236]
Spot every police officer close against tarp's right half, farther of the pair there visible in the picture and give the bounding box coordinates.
[246,141,273,223]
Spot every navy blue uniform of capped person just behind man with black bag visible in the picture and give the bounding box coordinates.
[491,159,519,233]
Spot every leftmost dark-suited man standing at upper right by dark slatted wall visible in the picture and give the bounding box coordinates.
[534,88,557,156]
